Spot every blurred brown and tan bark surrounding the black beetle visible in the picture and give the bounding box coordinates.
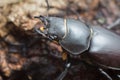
[0,0,120,80]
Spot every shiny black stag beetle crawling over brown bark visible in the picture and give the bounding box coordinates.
[35,16,120,80]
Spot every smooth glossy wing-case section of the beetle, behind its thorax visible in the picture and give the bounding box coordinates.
[89,27,120,70]
